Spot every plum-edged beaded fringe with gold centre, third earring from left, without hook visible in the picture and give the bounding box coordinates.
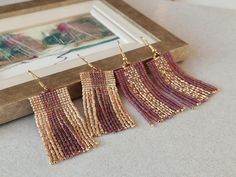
[115,62,184,125]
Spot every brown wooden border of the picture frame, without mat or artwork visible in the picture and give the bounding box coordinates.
[0,0,188,124]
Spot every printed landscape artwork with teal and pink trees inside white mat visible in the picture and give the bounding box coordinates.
[0,14,118,68]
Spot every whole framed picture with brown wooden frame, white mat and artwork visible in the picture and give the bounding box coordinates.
[0,0,187,123]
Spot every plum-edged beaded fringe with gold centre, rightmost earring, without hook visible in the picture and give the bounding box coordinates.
[147,53,217,108]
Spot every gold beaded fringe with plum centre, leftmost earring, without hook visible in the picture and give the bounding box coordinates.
[29,88,96,164]
